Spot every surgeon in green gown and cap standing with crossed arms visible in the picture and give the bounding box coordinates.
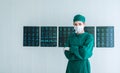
[64,14,94,73]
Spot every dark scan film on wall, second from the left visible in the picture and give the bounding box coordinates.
[40,26,57,47]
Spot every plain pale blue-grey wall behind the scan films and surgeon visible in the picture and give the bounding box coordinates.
[0,0,120,73]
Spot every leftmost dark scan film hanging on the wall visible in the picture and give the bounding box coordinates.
[23,26,39,46]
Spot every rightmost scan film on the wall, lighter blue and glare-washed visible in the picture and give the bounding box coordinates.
[96,26,114,47]
